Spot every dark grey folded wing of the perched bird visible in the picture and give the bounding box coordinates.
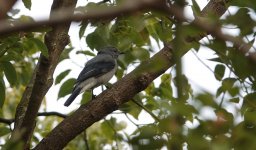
[76,61,115,83]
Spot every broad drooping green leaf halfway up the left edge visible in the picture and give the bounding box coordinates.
[1,61,17,86]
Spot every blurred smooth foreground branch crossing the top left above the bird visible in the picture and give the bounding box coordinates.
[0,0,164,35]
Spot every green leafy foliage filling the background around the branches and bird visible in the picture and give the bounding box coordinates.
[0,0,256,149]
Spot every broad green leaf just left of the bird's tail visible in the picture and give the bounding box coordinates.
[58,78,76,99]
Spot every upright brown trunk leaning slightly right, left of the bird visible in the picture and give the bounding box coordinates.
[12,0,76,149]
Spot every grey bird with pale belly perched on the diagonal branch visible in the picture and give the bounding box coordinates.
[64,47,122,106]
